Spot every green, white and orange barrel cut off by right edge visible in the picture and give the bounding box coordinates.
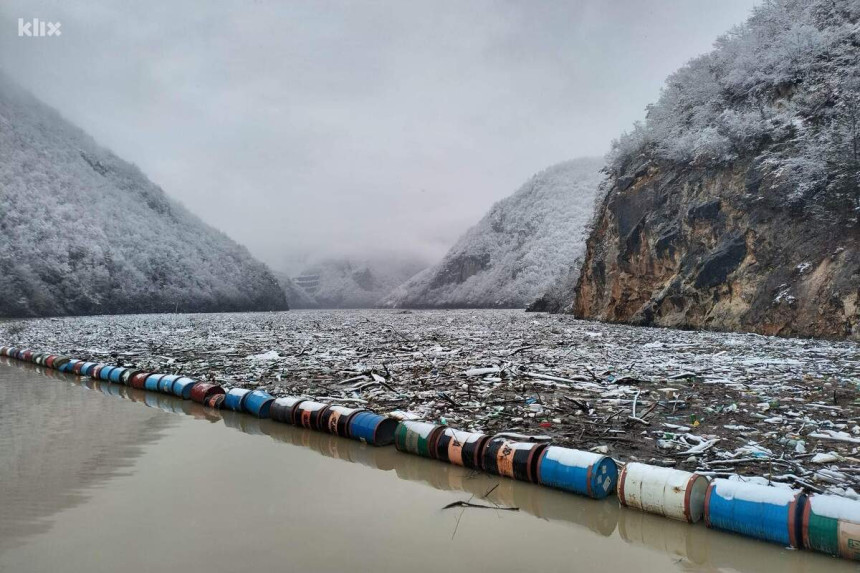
[802,495,860,561]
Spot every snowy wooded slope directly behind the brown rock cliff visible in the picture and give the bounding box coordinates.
[386,158,603,308]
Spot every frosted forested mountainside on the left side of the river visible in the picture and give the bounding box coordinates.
[0,74,286,316]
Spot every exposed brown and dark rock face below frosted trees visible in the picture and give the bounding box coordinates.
[574,161,860,338]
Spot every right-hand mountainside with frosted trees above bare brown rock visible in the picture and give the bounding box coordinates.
[570,0,860,338]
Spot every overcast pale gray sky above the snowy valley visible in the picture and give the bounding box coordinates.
[0,0,757,268]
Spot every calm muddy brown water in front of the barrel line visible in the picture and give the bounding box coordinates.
[0,359,857,573]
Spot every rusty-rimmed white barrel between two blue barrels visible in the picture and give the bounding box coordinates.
[618,462,708,523]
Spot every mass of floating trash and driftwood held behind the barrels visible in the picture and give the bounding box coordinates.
[0,310,860,497]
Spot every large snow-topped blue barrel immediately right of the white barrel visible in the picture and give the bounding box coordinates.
[705,479,806,547]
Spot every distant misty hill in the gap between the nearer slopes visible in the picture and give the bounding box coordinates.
[293,255,426,308]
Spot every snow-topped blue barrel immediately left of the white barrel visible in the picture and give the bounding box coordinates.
[538,446,618,499]
